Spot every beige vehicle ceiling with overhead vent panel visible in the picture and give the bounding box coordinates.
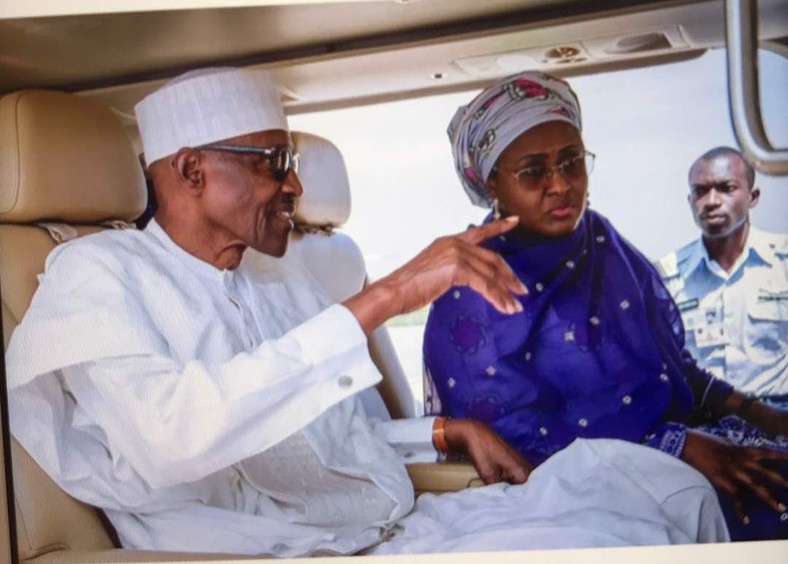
[0,0,788,125]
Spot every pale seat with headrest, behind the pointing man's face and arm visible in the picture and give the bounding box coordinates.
[291,132,415,419]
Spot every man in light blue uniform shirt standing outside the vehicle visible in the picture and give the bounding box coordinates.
[658,147,788,409]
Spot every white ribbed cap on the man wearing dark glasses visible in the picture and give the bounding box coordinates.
[134,67,288,165]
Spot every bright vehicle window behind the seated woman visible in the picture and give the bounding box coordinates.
[290,50,788,412]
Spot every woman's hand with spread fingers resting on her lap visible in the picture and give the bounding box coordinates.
[681,431,788,524]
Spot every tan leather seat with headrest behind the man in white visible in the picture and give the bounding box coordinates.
[0,90,145,561]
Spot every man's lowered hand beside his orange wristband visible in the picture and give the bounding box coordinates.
[444,419,533,484]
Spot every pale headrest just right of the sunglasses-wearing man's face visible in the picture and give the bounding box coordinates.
[291,131,350,227]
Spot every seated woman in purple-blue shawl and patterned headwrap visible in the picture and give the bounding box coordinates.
[424,72,788,540]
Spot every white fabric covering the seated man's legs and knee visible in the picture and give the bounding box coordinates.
[368,439,729,554]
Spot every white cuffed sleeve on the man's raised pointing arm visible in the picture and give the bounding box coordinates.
[62,305,380,488]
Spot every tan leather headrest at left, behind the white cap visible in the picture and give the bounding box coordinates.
[0,90,147,223]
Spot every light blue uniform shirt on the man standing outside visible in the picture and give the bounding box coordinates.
[657,226,788,397]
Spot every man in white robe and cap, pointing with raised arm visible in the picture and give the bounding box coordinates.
[7,69,728,556]
